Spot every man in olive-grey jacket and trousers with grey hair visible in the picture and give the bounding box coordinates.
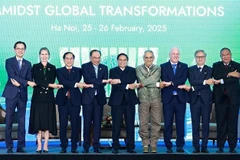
[136,50,162,153]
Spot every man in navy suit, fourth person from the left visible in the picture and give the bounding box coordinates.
[82,49,109,153]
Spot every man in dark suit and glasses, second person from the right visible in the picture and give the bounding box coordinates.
[188,50,214,153]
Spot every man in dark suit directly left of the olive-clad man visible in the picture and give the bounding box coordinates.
[108,53,139,154]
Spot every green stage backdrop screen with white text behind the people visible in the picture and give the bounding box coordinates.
[0,0,240,100]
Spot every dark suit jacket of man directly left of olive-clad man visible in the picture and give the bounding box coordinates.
[108,66,138,106]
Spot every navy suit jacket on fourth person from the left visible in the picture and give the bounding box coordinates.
[82,62,108,105]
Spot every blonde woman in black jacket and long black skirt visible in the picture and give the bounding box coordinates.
[29,47,62,153]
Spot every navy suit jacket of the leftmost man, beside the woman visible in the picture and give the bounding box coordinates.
[2,57,32,102]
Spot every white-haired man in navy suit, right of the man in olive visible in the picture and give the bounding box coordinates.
[160,48,189,153]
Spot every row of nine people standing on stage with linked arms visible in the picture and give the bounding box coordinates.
[3,41,240,154]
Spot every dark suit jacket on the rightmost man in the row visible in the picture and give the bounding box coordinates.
[213,61,240,104]
